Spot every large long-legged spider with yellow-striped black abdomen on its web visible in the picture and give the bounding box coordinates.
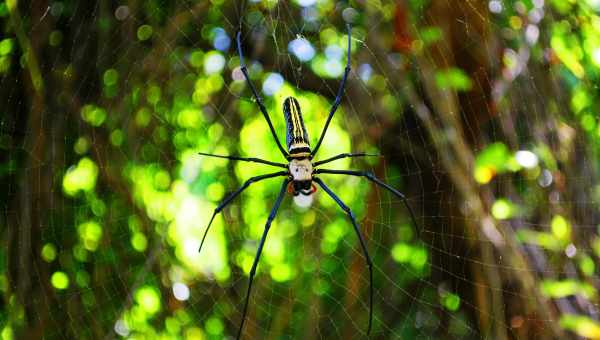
[198,25,417,339]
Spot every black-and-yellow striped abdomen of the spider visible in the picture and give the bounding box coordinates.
[283,97,310,158]
